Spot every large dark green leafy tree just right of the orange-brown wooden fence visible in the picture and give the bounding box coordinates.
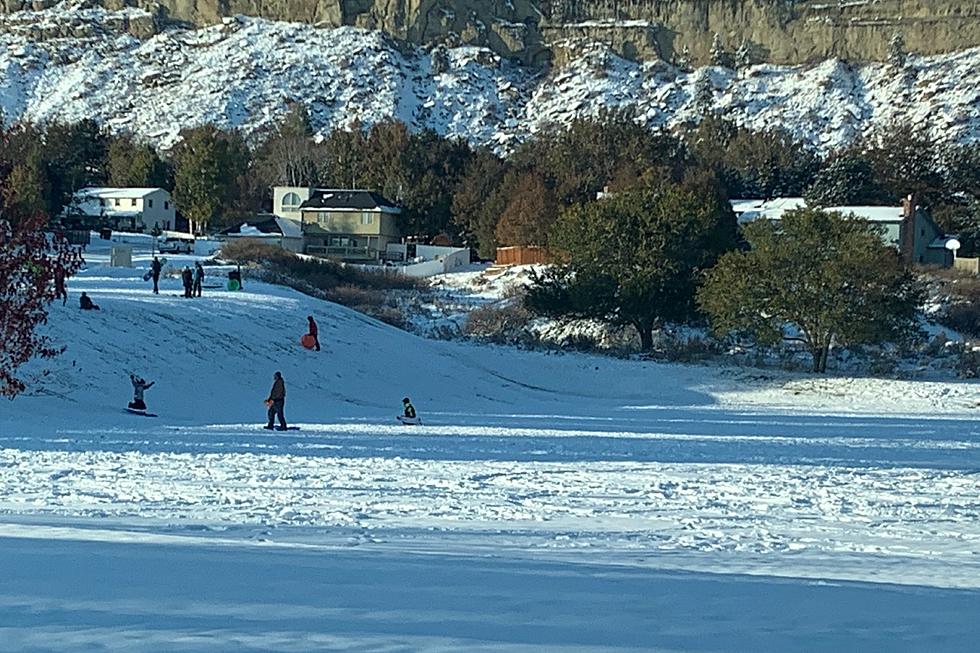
[527,179,735,351]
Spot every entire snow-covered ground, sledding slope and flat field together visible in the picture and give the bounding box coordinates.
[0,245,980,652]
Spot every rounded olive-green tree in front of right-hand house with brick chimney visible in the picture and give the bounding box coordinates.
[698,209,921,372]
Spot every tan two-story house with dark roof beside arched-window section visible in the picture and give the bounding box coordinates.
[294,188,401,262]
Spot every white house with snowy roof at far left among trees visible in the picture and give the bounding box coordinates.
[65,188,177,231]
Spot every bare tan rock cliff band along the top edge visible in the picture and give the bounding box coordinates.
[0,0,980,64]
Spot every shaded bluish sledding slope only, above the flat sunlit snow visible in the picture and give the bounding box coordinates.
[4,242,710,426]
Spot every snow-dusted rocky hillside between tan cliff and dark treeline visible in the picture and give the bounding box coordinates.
[0,2,980,149]
